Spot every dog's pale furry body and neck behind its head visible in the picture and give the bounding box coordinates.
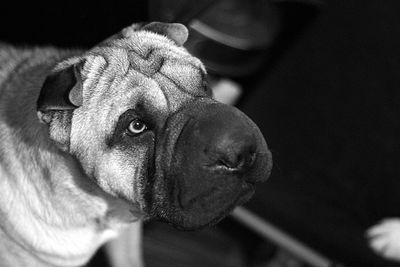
[0,47,137,266]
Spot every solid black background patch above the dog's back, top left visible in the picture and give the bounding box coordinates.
[0,0,148,48]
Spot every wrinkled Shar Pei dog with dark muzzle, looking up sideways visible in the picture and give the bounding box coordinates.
[0,22,272,266]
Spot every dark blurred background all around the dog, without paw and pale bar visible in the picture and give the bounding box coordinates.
[0,0,400,267]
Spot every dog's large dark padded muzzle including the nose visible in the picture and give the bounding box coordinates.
[147,99,272,229]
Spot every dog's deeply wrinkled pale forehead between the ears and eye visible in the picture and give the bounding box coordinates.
[91,31,207,112]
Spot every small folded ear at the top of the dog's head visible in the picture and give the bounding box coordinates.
[141,22,189,46]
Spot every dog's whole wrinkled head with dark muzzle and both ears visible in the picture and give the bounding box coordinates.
[38,23,272,229]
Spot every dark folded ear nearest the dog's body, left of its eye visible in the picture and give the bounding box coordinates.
[37,60,85,113]
